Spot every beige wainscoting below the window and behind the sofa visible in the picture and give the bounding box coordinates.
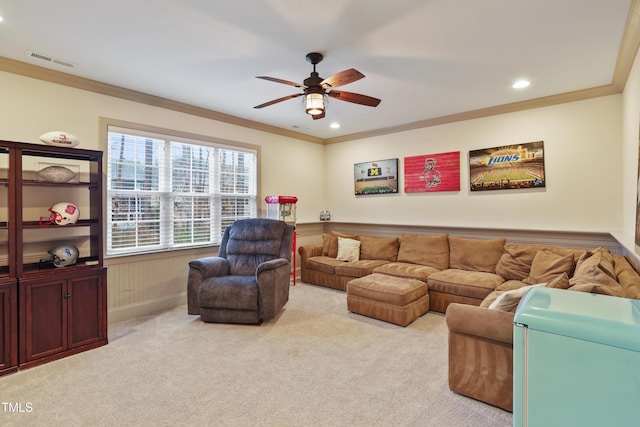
[105,221,638,322]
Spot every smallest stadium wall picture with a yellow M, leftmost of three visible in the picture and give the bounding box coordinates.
[353,158,398,196]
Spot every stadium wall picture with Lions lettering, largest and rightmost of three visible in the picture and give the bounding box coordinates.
[469,141,546,191]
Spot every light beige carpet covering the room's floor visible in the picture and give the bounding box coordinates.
[0,283,512,427]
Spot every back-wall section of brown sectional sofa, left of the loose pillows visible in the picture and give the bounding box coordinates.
[298,232,505,313]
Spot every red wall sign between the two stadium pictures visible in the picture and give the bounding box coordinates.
[404,151,460,193]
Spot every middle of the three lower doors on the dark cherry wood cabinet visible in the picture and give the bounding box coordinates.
[20,278,68,363]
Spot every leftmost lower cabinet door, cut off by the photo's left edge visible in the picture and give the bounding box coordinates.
[0,284,18,375]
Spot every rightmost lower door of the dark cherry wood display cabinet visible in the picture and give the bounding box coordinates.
[67,270,106,348]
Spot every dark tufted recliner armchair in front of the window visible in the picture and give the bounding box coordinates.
[187,218,294,324]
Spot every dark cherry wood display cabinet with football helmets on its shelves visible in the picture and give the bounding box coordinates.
[0,141,107,374]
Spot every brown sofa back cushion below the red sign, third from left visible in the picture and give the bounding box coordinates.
[398,233,449,270]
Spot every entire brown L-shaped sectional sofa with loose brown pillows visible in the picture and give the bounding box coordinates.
[299,231,640,411]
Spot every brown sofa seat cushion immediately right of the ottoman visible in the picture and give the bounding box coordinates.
[427,268,504,300]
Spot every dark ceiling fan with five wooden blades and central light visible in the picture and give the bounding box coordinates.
[254,52,380,120]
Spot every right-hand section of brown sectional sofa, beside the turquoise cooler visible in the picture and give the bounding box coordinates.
[446,244,640,411]
